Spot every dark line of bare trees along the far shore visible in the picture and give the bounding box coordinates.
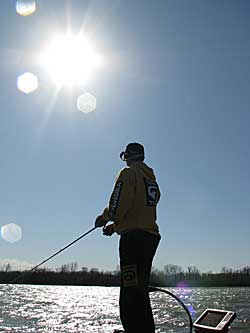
[0,262,250,287]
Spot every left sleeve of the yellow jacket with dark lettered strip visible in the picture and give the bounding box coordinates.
[103,168,135,223]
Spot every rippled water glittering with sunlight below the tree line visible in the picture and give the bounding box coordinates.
[0,285,250,333]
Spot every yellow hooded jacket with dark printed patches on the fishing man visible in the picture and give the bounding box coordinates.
[103,162,160,235]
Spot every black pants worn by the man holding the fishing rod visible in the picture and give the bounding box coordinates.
[119,230,160,333]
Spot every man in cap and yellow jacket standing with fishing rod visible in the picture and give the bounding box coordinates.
[95,143,160,333]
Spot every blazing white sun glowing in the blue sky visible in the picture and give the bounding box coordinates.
[39,34,102,86]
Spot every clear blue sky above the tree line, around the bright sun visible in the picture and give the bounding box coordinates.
[0,0,250,272]
